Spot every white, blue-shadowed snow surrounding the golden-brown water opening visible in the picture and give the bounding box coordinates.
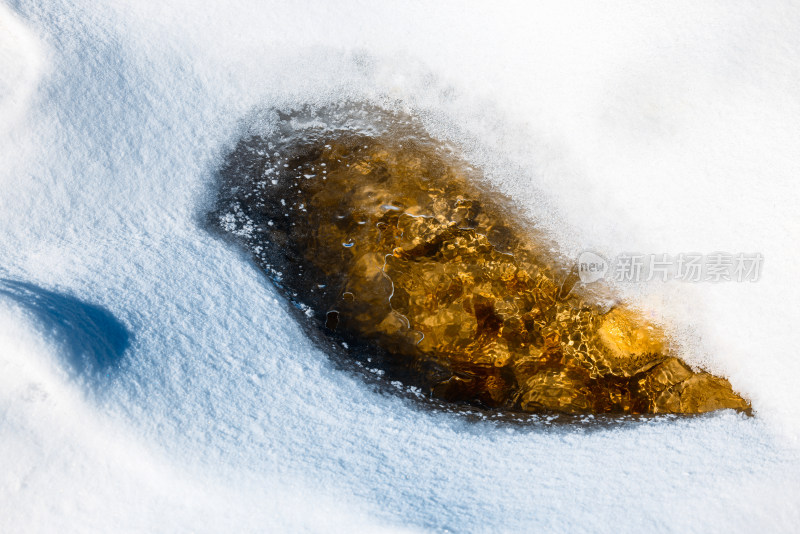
[0,0,800,532]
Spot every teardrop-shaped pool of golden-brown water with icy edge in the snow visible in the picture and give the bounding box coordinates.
[212,109,749,414]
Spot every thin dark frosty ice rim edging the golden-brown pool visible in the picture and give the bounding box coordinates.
[206,101,753,428]
